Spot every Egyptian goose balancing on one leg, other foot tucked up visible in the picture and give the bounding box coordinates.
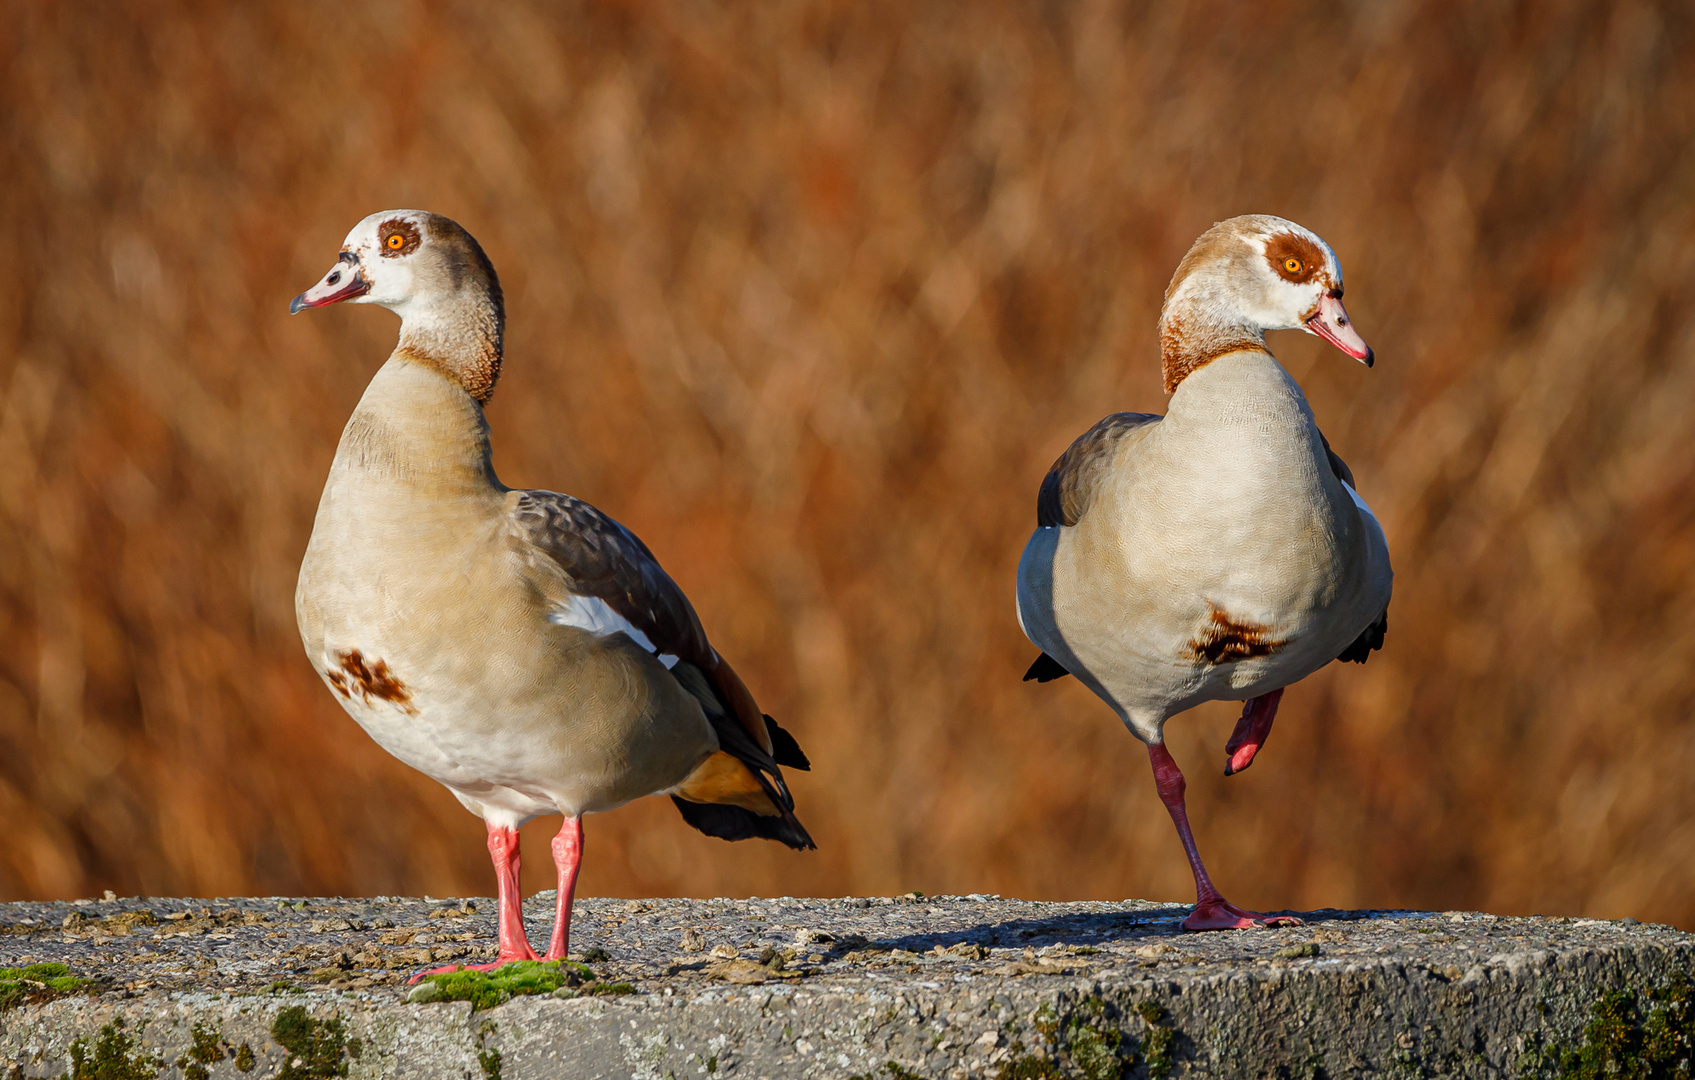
[1017,215,1392,929]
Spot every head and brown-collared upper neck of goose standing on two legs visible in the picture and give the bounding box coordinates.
[288,210,505,404]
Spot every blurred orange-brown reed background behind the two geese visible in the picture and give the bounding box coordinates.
[0,0,1695,927]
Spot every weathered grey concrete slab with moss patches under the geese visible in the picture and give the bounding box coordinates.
[0,894,1695,1080]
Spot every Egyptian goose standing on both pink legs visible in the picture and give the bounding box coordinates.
[288,210,814,966]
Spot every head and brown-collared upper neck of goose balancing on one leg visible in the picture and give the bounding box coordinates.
[1159,214,1375,390]
